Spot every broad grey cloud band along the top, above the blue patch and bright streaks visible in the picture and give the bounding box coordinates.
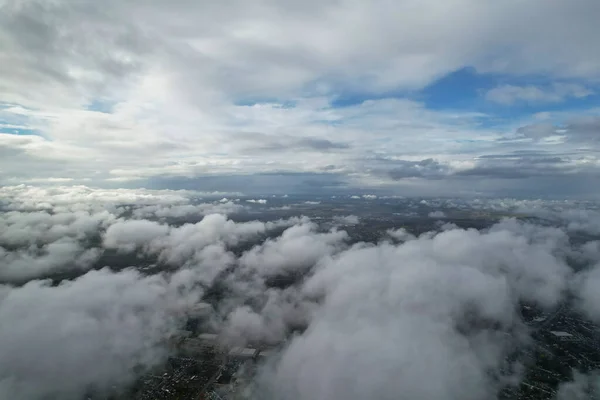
[1,1,598,107]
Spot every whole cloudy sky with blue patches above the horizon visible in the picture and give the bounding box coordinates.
[0,0,600,198]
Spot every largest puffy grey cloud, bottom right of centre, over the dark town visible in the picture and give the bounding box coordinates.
[262,223,569,399]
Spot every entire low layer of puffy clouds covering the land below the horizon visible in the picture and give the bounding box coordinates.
[0,187,600,400]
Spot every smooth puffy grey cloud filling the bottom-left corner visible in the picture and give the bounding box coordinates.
[0,269,200,399]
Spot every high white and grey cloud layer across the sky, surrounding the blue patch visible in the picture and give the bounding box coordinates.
[0,0,600,192]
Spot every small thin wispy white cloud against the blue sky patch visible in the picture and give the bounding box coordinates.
[485,83,594,105]
